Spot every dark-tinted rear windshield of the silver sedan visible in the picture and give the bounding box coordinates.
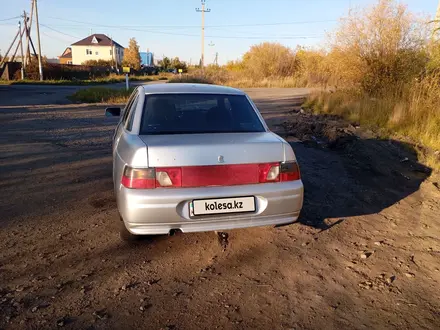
[139,94,264,135]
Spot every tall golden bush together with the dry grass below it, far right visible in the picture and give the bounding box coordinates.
[305,0,440,169]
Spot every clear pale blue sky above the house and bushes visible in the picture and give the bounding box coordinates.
[0,0,438,64]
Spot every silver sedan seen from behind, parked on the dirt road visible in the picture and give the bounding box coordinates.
[106,84,303,240]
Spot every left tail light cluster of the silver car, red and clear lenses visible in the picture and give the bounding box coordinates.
[121,166,182,189]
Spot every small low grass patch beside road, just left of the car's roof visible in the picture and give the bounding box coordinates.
[68,87,134,103]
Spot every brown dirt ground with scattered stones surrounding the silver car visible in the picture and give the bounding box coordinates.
[0,89,440,329]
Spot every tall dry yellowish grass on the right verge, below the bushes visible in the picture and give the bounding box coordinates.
[304,75,440,170]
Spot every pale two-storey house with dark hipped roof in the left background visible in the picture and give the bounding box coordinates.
[69,34,124,65]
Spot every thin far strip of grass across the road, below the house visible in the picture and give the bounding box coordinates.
[0,75,168,86]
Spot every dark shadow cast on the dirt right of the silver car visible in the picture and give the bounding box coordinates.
[292,139,431,230]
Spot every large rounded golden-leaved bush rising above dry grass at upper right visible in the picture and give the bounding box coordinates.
[329,0,427,95]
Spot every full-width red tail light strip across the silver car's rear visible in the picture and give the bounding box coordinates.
[121,162,301,189]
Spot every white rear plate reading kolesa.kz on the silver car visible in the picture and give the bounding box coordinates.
[191,196,255,215]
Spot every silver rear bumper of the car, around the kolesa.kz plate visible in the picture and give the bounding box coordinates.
[116,180,304,235]
